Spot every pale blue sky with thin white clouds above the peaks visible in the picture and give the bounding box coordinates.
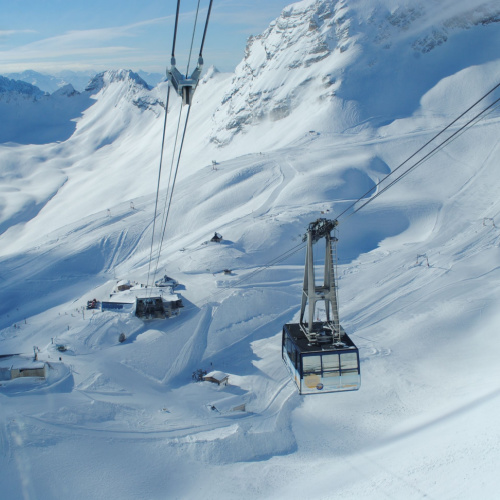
[0,0,293,74]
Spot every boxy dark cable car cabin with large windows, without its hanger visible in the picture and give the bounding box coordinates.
[282,323,361,394]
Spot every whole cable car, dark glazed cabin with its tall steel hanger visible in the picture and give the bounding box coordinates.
[282,219,361,394]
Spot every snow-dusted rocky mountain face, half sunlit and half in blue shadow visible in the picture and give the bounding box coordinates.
[211,0,500,145]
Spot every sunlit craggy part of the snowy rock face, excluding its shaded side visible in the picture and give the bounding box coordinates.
[212,1,352,144]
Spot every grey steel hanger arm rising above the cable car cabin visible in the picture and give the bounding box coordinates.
[299,218,341,343]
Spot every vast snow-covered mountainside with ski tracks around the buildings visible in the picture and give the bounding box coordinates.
[0,0,500,499]
